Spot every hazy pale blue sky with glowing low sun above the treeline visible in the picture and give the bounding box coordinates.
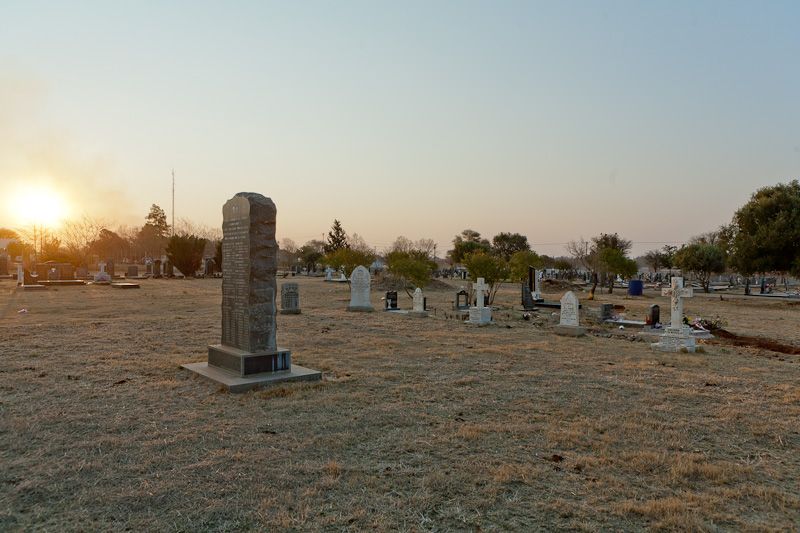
[0,0,800,255]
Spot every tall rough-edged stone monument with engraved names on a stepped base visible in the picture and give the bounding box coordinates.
[182,192,322,392]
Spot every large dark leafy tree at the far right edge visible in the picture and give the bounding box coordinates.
[723,180,800,276]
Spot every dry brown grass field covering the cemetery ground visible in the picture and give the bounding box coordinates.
[0,277,800,531]
